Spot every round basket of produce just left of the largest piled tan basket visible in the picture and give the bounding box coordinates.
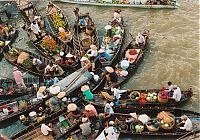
[146,119,160,132]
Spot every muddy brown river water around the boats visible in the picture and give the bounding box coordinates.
[0,0,200,140]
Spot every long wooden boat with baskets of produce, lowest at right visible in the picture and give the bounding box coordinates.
[108,108,200,136]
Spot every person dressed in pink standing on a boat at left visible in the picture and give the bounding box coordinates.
[13,66,26,91]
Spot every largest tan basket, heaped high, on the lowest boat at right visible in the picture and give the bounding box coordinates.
[157,111,175,130]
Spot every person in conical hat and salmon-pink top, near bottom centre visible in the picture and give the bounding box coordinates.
[83,104,98,120]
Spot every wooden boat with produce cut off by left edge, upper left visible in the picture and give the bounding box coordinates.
[0,23,18,61]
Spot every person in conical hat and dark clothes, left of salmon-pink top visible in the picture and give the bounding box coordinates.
[67,103,81,117]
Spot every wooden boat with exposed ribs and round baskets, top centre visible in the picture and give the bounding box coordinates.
[73,8,99,52]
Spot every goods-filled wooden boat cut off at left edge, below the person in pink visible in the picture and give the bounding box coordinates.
[0,95,42,124]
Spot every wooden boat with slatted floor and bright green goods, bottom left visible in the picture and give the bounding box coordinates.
[12,100,84,140]
